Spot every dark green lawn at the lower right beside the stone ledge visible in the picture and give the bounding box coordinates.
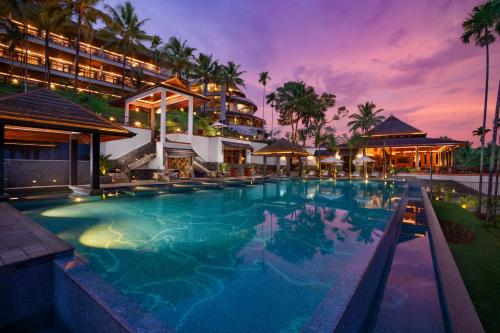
[433,201,500,332]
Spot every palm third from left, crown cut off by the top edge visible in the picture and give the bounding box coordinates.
[64,0,106,102]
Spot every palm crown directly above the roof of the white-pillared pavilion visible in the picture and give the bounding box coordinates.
[163,37,196,78]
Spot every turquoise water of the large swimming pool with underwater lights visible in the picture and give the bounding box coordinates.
[16,181,403,332]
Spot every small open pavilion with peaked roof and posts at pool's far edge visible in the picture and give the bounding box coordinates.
[253,138,311,176]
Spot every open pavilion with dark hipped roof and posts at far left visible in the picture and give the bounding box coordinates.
[0,89,135,198]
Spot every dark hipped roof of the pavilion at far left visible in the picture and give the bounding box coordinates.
[0,88,135,137]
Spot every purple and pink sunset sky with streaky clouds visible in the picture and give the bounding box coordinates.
[106,0,500,145]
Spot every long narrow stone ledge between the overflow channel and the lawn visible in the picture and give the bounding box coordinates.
[421,188,484,333]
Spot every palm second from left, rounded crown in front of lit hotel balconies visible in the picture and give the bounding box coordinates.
[34,0,70,88]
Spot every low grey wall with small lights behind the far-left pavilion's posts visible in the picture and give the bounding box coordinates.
[5,160,90,187]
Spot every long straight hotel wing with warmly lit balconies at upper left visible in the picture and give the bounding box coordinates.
[0,18,168,95]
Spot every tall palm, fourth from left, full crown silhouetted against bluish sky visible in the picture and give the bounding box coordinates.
[105,1,147,94]
